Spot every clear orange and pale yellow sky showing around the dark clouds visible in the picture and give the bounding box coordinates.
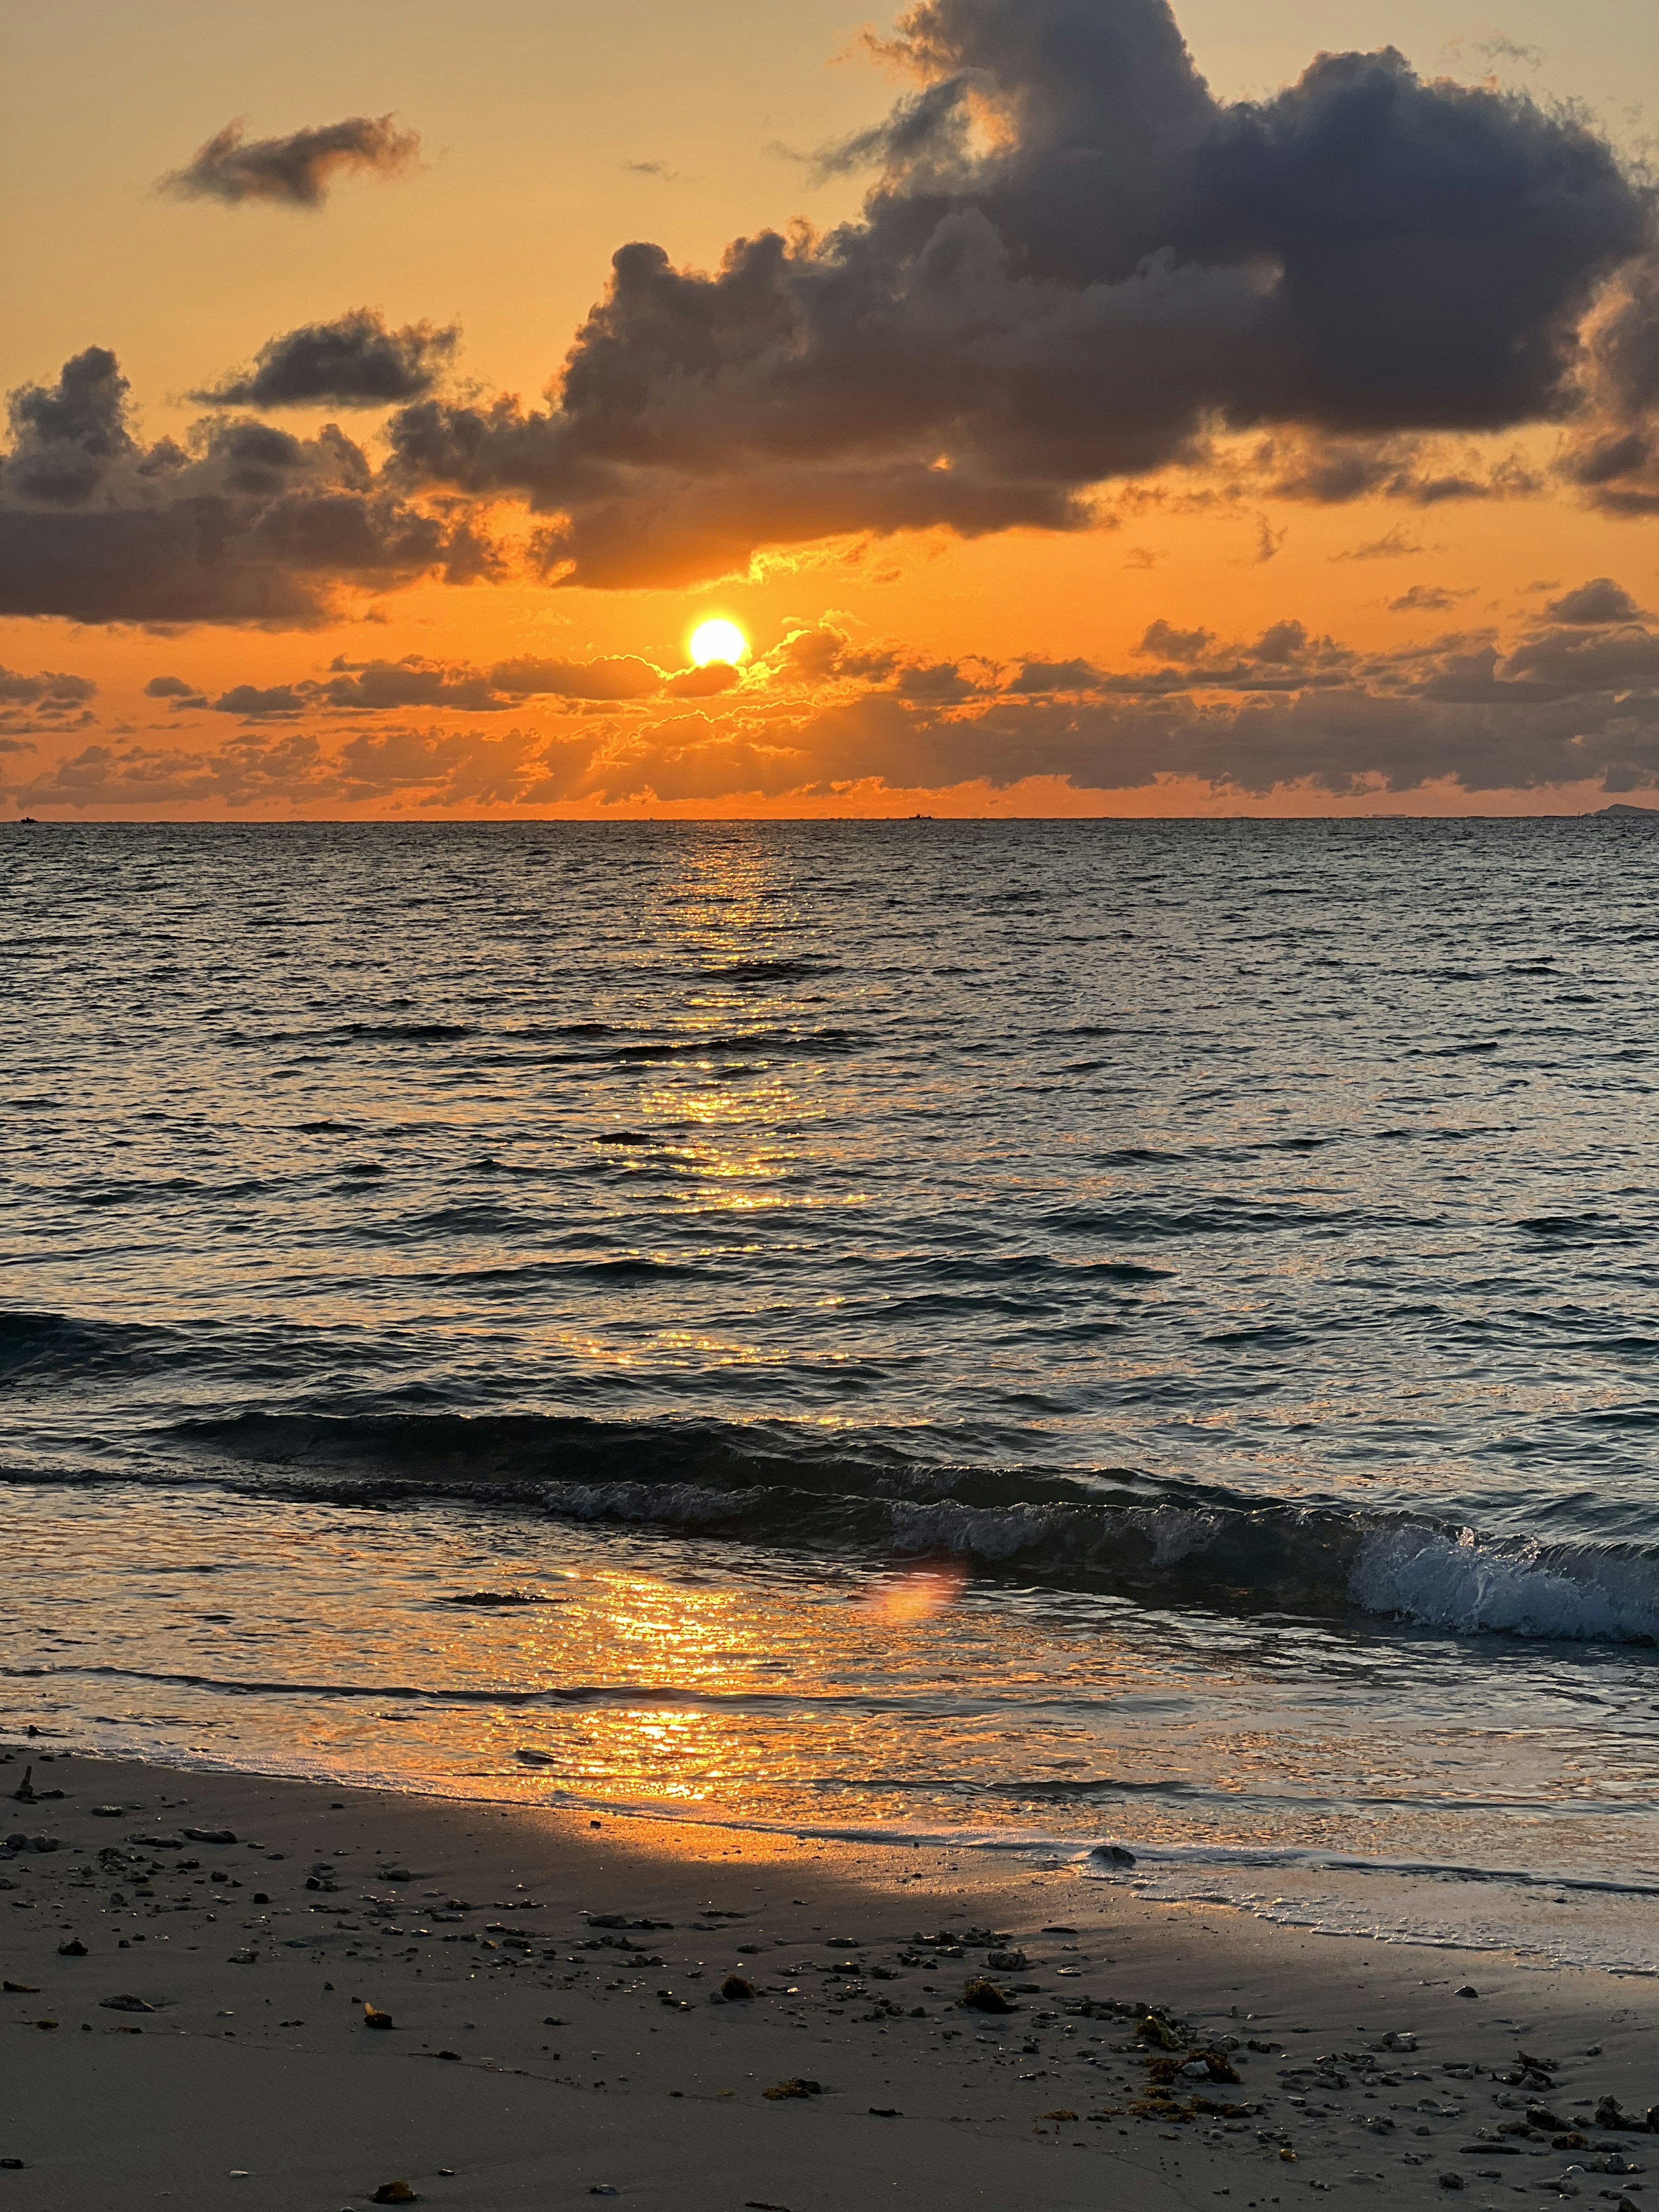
[0,0,1659,821]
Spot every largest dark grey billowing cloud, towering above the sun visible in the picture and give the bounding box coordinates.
[391,0,1650,586]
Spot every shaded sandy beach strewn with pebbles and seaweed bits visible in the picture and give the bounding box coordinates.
[0,1745,1659,2212]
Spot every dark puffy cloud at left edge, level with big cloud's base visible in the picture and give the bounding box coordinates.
[0,345,498,626]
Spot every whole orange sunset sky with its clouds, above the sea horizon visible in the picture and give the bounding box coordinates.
[0,0,1659,821]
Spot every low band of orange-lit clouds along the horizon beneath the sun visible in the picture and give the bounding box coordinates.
[19,577,1659,812]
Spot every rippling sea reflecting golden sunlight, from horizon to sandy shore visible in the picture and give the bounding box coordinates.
[0,816,1659,1971]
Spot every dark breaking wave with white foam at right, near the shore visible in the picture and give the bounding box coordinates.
[0,1411,1659,1643]
